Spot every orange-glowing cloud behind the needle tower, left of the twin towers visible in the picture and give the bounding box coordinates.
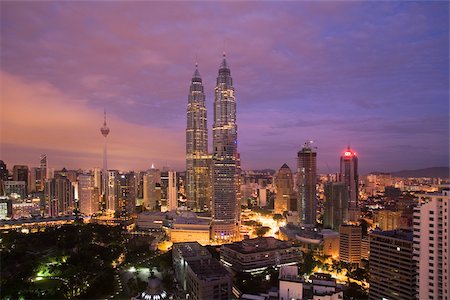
[1,72,184,169]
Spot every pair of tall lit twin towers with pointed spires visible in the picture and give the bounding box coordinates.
[186,54,240,240]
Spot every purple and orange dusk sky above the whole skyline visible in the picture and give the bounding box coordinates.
[0,1,449,172]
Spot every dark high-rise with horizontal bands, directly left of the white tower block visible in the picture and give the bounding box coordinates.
[369,230,416,300]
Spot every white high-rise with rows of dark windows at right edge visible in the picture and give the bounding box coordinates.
[413,190,450,300]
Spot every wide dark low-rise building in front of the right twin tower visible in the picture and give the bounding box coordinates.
[220,237,301,272]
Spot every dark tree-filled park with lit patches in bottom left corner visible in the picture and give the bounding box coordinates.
[0,224,126,299]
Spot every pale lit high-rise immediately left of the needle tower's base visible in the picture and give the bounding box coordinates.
[78,174,100,216]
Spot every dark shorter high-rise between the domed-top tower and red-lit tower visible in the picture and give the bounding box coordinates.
[323,182,348,231]
